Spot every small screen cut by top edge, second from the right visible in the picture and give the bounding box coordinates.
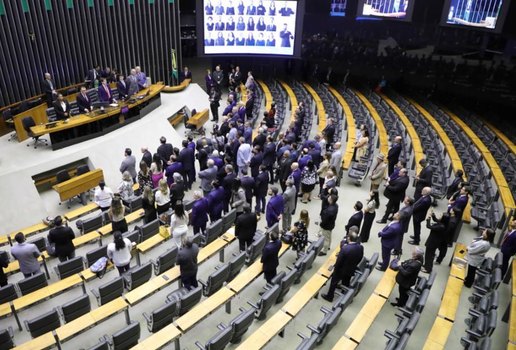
[357,0,415,21]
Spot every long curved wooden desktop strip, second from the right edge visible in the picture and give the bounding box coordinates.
[443,108,515,220]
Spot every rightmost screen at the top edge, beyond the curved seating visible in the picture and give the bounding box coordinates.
[441,0,510,32]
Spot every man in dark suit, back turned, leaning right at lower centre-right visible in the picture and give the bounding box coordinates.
[321,232,364,302]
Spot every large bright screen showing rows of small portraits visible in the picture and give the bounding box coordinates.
[203,0,297,55]
